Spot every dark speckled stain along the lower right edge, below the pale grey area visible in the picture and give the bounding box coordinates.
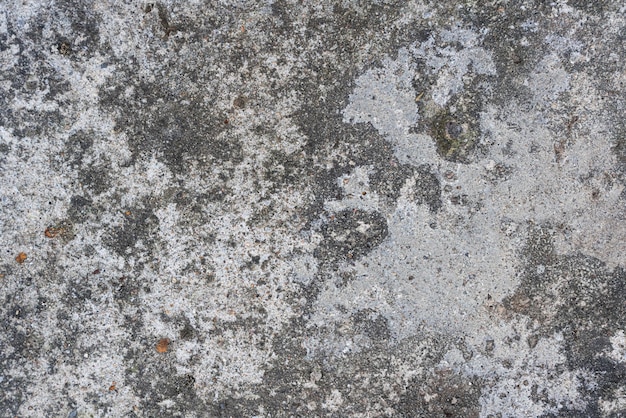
[504,229,626,416]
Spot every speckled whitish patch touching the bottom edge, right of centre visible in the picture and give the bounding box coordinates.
[454,319,594,417]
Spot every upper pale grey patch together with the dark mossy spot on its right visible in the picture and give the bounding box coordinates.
[343,24,495,165]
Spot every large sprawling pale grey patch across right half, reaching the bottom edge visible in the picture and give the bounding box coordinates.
[311,18,626,416]
